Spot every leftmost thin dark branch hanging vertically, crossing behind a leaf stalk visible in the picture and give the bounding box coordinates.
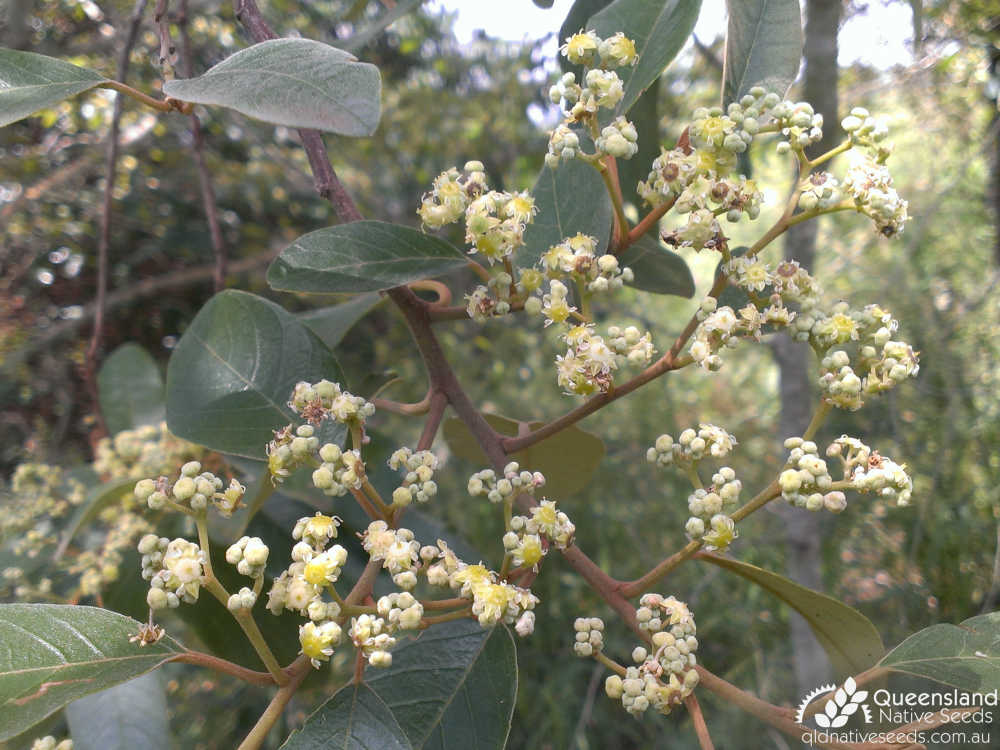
[84,0,147,433]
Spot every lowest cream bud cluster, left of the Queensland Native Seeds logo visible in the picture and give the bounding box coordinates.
[604,594,698,716]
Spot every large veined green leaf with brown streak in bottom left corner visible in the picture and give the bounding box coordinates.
[0,604,184,740]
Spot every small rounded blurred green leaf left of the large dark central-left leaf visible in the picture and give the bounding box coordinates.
[97,344,166,435]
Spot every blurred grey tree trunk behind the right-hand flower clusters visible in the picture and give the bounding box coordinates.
[773,0,842,693]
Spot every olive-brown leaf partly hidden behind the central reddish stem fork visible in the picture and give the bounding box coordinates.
[443,414,604,499]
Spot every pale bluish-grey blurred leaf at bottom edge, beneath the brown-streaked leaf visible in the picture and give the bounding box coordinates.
[66,672,170,750]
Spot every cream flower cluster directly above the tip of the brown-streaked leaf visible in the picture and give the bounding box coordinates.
[138,534,205,609]
